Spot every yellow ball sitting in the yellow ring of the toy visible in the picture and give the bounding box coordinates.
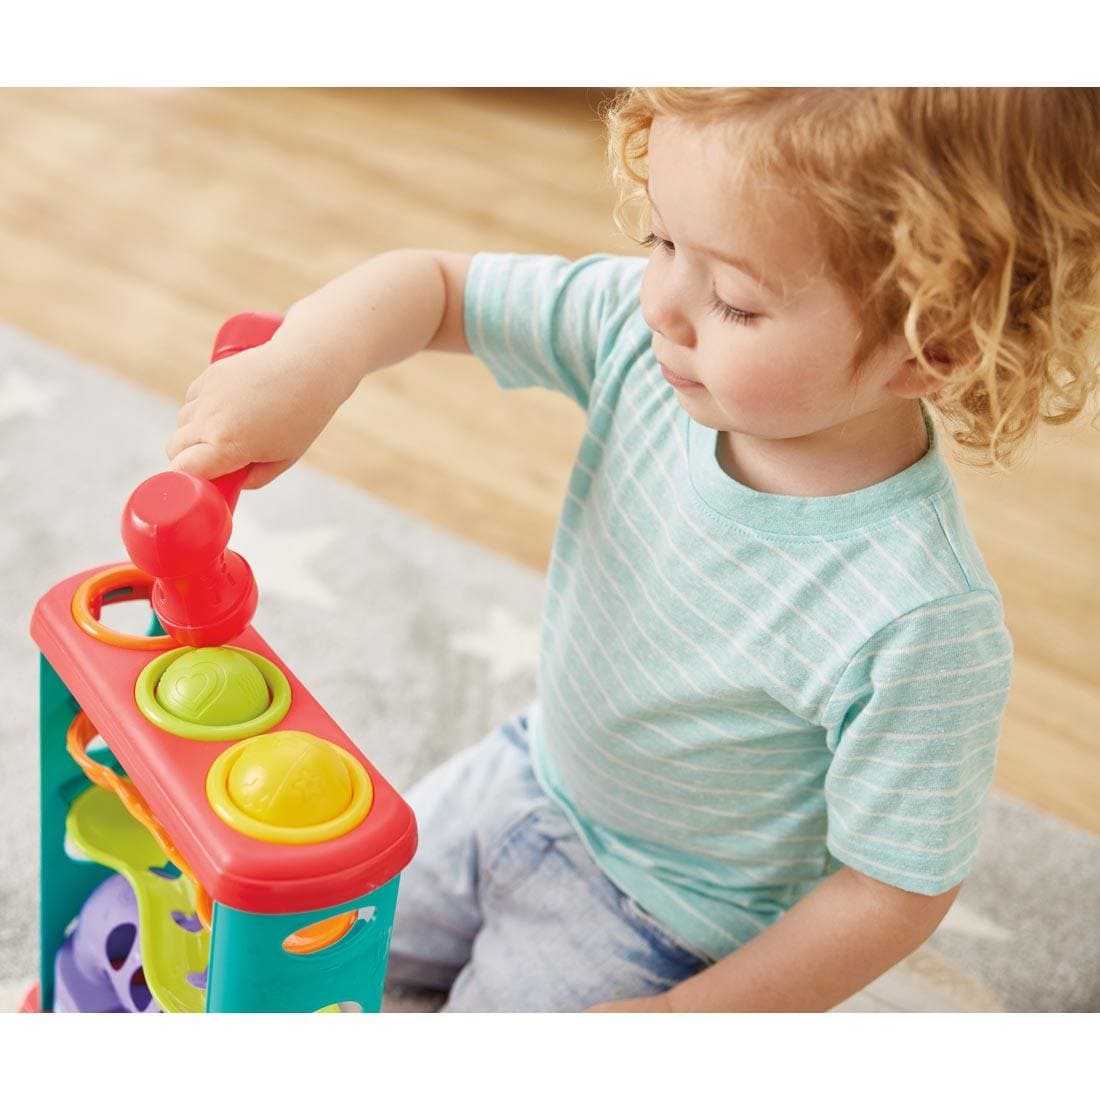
[226,729,352,828]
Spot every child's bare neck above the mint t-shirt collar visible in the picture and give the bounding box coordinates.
[716,399,930,496]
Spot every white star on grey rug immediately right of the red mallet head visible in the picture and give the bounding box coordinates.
[229,512,340,611]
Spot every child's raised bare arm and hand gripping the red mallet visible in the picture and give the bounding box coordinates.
[165,250,470,487]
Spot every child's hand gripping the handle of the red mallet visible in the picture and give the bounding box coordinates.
[165,333,350,488]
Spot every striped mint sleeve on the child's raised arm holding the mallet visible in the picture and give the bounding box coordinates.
[463,252,645,408]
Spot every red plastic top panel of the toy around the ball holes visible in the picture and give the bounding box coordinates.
[31,570,417,913]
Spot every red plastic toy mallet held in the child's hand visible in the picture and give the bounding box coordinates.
[122,314,281,646]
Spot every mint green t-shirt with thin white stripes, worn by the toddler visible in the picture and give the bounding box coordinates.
[464,253,1012,959]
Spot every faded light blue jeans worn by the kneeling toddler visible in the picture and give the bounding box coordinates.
[388,715,706,1012]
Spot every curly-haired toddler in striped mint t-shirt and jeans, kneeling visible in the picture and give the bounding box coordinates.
[167,88,1100,1011]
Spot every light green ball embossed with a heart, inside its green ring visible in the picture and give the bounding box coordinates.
[156,646,271,726]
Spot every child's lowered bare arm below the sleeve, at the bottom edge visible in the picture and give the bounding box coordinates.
[590,868,961,1012]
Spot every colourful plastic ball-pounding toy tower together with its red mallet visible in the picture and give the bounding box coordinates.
[31,315,416,1012]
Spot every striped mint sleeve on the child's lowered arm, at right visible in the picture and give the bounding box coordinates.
[825,591,1012,894]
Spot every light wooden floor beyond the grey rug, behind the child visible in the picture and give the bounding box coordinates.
[0,89,1100,831]
